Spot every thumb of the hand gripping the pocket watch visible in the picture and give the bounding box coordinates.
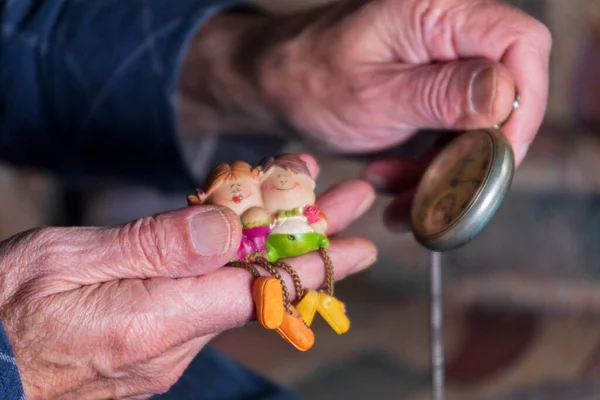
[391,60,515,129]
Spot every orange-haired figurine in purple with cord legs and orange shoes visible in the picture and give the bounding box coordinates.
[188,161,314,351]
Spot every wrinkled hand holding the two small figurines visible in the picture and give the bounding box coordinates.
[0,157,376,400]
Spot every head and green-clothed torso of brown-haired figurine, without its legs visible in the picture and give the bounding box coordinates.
[258,154,329,262]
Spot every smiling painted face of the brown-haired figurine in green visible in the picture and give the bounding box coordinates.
[261,165,315,213]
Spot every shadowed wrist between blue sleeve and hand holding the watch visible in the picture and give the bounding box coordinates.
[177,7,276,138]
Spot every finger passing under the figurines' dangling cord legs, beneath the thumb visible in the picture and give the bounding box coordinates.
[140,238,377,344]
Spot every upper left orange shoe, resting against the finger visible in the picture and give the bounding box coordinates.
[252,276,285,330]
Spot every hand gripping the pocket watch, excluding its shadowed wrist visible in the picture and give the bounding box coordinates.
[252,0,551,229]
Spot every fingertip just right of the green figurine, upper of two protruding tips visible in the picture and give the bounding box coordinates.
[317,180,375,235]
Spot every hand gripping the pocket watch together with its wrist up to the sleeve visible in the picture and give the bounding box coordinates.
[185,0,551,231]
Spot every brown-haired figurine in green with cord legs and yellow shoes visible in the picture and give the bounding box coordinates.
[258,154,350,335]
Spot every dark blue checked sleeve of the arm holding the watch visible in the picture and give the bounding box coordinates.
[0,0,239,191]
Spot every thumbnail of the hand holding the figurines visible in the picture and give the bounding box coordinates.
[190,208,232,257]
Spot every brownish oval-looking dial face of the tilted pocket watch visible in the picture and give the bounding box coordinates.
[412,130,494,236]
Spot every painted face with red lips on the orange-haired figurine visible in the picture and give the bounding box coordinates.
[206,176,263,215]
